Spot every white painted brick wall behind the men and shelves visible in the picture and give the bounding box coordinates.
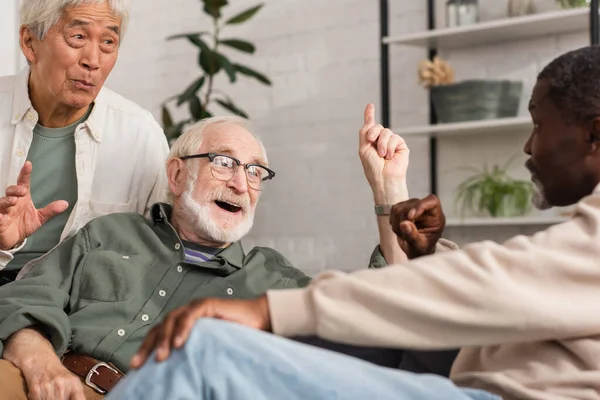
[0,0,587,274]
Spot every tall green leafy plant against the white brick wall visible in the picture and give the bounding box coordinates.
[162,0,271,140]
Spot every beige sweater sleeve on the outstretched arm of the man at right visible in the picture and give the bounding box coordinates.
[268,194,600,349]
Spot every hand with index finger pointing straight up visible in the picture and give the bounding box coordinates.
[358,104,410,204]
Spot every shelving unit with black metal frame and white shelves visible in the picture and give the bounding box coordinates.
[380,0,600,227]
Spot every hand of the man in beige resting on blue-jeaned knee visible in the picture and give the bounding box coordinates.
[130,295,271,368]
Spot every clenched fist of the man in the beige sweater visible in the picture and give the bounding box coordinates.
[390,194,446,259]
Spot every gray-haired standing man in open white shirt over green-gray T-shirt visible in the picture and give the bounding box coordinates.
[0,0,168,285]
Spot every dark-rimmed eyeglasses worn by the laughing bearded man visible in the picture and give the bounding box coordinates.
[179,153,275,190]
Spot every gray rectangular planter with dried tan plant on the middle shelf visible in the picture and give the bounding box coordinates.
[419,57,523,123]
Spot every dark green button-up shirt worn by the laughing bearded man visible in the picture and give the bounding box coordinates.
[0,204,310,371]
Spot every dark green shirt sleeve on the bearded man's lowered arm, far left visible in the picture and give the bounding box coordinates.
[0,228,87,358]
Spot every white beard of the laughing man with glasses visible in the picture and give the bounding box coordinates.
[180,182,254,243]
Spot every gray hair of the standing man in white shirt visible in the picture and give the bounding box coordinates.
[20,0,129,40]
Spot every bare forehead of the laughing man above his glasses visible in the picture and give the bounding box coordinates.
[199,124,267,165]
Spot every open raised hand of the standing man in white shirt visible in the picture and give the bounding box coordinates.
[0,161,69,250]
